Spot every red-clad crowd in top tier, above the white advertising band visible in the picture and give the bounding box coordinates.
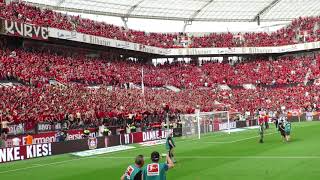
[0,2,320,48]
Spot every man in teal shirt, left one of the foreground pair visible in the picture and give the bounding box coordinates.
[121,155,144,180]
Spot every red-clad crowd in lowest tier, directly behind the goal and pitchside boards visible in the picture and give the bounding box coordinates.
[0,85,320,128]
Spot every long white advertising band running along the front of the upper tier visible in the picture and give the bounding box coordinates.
[49,28,320,56]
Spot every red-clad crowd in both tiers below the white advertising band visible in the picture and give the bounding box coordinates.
[0,46,320,124]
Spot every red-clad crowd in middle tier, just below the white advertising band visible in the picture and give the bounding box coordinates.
[0,49,320,89]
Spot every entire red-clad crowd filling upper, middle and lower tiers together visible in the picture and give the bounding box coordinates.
[0,3,320,128]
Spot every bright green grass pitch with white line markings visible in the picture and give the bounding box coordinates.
[0,122,320,180]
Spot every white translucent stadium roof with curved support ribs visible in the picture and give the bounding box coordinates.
[24,0,320,22]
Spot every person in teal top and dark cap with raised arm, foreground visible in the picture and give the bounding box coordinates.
[142,151,174,180]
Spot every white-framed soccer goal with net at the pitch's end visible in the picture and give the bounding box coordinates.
[180,111,230,139]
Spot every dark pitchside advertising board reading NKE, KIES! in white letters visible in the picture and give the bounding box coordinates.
[0,129,173,163]
